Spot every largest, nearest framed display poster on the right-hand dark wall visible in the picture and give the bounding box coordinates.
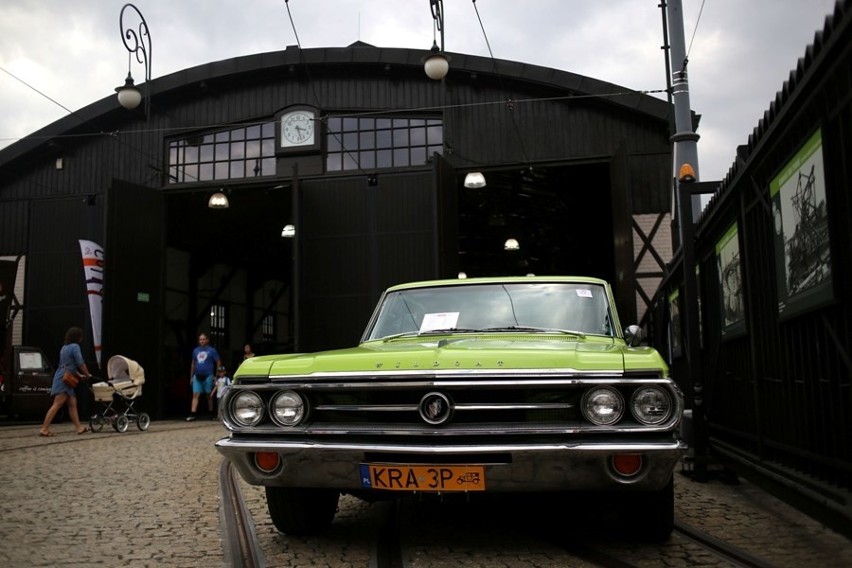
[769,130,832,317]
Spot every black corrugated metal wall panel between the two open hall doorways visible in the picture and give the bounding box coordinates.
[298,171,439,351]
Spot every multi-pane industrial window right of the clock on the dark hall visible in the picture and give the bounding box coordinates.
[326,117,444,172]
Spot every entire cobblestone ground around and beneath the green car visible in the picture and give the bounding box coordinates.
[0,421,852,568]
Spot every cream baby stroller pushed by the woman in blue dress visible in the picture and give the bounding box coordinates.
[89,355,151,432]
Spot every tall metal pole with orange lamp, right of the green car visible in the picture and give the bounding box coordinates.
[666,0,707,481]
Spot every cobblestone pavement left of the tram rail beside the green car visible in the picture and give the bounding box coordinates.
[0,421,224,568]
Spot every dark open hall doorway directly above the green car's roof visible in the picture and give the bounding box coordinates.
[459,164,615,282]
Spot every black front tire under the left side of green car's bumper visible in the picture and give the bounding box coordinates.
[266,487,340,536]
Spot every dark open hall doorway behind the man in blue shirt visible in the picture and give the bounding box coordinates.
[163,185,293,413]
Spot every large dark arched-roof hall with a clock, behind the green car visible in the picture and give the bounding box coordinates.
[0,43,671,415]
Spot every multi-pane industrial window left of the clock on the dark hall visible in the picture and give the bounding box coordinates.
[169,122,275,183]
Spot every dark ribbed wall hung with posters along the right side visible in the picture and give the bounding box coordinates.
[648,0,852,534]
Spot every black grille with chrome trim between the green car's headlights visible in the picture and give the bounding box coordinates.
[226,375,678,437]
